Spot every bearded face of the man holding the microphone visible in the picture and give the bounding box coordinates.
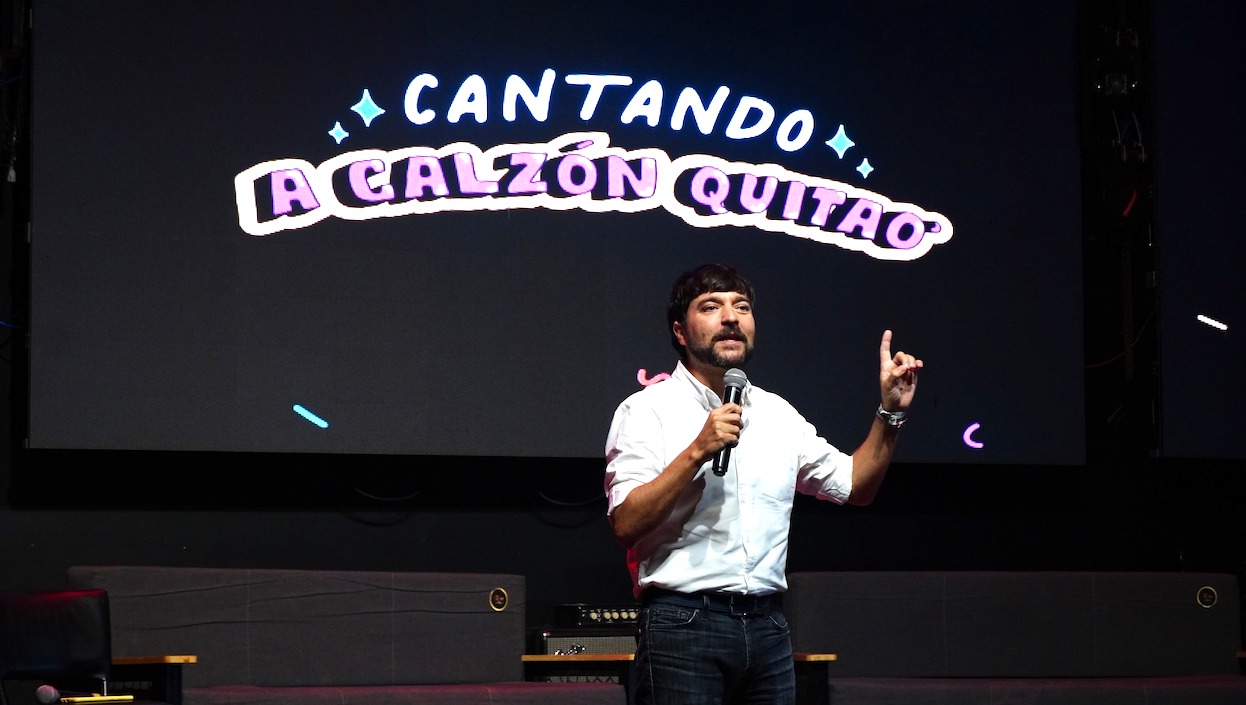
[674,291,756,370]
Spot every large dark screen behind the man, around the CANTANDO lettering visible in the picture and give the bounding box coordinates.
[25,0,1085,473]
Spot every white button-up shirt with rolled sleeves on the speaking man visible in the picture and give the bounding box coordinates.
[606,362,852,598]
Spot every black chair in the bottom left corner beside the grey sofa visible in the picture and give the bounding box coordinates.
[0,589,122,705]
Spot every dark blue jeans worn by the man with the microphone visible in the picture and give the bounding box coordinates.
[632,594,796,705]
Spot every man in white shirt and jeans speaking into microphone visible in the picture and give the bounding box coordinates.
[606,264,922,705]
